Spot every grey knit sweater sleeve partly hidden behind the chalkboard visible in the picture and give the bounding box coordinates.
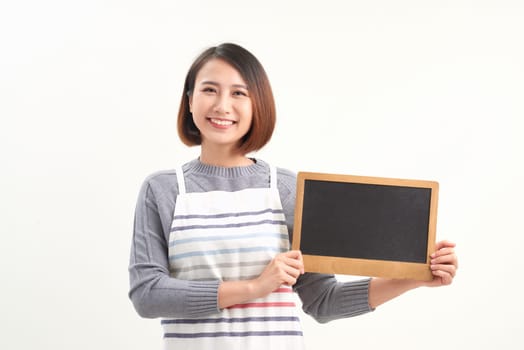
[279,171,372,323]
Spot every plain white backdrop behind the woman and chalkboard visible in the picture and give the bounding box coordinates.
[0,0,524,350]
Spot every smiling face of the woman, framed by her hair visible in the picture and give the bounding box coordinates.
[189,59,253,152]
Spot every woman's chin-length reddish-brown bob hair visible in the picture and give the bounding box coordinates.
[177,43,276,154]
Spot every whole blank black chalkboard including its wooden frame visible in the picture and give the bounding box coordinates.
[293,172,438,280]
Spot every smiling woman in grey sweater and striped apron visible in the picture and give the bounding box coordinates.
[129,44,457,350]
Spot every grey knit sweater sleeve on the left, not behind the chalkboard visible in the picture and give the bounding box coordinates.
[129,173,219,318]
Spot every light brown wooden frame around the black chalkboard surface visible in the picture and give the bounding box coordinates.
[292,172,439,280]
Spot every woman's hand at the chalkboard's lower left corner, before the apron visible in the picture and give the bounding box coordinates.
[253,250,304,297]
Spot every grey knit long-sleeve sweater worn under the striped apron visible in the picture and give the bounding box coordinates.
[129,159,371,322]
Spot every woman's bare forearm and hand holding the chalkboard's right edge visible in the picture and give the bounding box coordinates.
[369,241,458,308]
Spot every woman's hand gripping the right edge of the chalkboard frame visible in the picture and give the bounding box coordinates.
[424,241,458,287]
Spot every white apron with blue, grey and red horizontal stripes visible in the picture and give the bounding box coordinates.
[162,167,304,350]
